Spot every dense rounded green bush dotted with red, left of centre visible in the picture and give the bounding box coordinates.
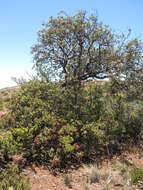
[9,81,106,167]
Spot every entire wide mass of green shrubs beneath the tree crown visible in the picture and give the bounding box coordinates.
[3,81,143,167]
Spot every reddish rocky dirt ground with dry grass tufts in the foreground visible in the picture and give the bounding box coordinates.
[21,153,143,190]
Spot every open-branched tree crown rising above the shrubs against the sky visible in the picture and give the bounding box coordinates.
[32,11,142,86]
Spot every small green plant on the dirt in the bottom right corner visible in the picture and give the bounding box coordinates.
[130,168,143,184]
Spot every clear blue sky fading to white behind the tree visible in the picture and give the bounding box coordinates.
[0,0,143,88]
